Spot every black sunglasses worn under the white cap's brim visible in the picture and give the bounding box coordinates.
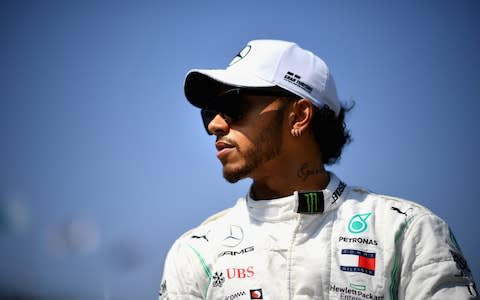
[200,87,301,135]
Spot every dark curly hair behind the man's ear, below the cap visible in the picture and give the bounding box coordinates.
[311,104,353,165]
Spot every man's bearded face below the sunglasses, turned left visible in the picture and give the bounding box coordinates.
[208,96,286,183]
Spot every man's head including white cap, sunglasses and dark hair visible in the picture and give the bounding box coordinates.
[185,40,350,182]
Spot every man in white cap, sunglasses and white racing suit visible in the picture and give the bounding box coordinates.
[160,40,477,300]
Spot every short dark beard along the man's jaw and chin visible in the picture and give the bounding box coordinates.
[223,109,284,183]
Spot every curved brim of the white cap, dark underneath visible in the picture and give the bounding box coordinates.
[184,69,275,108]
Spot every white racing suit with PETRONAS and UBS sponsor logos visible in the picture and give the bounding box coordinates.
[159,173,477,300]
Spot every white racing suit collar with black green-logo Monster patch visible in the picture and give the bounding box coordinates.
[246,172,346,222]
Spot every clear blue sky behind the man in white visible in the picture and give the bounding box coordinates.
[0,0,480,300]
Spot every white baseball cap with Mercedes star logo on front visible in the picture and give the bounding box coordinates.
[184,40,341,116]
